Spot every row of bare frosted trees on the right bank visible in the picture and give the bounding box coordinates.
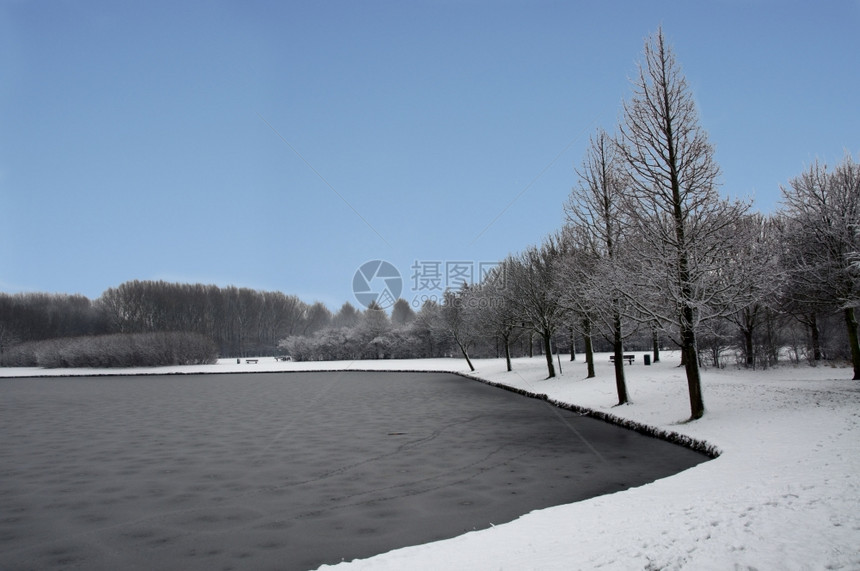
[434,30,860,419]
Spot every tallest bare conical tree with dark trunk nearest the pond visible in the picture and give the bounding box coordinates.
[618,29,748,419]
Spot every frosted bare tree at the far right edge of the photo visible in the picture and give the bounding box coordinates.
[782,155,860,380]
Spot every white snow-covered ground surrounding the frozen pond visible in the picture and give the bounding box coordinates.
[0,353,860,570]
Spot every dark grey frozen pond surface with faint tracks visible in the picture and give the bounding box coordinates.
[0,372,707,570]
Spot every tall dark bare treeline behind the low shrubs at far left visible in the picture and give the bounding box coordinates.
[0,281,332,357]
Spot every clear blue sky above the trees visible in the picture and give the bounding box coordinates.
[0,0,860,309]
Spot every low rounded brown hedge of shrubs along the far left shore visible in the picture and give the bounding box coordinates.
[2,332,218,368]
